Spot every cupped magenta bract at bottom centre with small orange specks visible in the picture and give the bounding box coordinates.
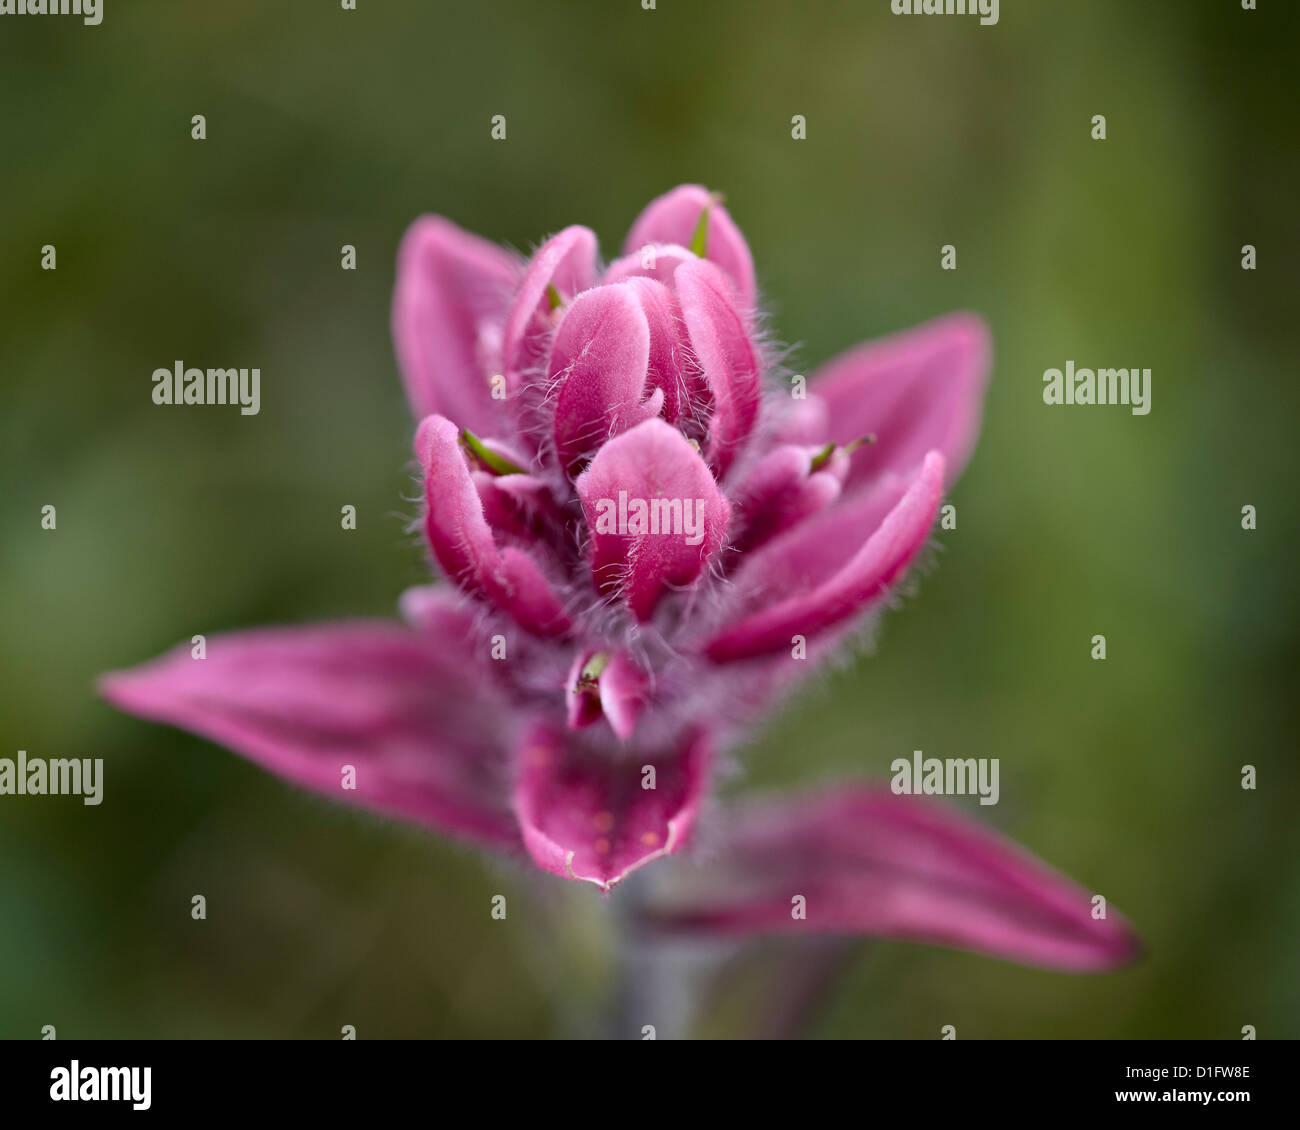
[515,726,710,891]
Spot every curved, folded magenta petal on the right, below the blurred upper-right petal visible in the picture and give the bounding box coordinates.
[706,451,944,663]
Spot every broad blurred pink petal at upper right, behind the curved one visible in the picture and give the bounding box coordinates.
[810,313,992,486]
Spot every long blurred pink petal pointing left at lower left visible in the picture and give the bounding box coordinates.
[100,620,519,845]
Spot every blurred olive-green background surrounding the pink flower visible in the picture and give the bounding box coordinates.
[0,0,1300,1039]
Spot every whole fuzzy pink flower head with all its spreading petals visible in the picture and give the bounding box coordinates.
[103,185,1135,970]
